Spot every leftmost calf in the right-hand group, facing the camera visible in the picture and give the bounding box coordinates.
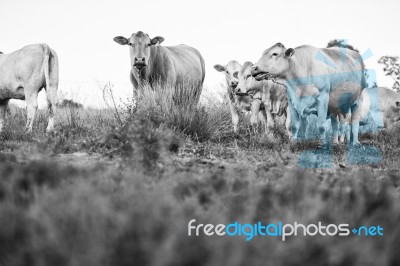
[214,60,251,132]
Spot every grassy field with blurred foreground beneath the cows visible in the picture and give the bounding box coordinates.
[0,85,400,266]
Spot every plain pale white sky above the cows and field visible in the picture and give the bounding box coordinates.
[0,0,400,107]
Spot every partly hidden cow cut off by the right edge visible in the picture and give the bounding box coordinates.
[360,87,400,128]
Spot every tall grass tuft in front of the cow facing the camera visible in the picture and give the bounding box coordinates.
[130,84,231,142]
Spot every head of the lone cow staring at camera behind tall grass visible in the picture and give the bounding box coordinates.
[114,31,164,70]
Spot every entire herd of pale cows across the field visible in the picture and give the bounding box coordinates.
[0,31,400,144]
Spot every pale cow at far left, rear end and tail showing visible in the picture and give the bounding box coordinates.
[0,44,58,133]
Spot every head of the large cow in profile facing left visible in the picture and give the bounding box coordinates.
[251,43,295,80]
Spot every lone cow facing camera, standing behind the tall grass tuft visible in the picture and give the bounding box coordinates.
[114,31,205,102]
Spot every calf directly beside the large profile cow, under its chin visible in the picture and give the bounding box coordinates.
[234,62,287,135]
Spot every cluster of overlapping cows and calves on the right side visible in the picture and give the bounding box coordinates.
[219,43,400,145]
